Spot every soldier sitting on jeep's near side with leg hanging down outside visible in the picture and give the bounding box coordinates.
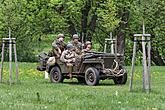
[60,43,77,79]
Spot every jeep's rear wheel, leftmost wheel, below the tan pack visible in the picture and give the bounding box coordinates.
[50,67,63,83]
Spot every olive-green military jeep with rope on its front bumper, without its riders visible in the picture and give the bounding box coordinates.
[37,52,127,86]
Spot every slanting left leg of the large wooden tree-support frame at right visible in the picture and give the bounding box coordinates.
[129,36,137,91]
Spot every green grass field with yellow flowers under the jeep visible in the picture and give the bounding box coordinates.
[0,63,165,110]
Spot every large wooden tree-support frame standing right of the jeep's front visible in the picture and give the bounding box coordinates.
[129,22,151,92]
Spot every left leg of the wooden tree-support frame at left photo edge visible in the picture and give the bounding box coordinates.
[0,40,5,82]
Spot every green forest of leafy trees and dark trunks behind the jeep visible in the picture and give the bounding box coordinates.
[0,0,165,66]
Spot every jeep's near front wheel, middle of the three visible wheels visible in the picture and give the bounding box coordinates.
[85,67,99,86]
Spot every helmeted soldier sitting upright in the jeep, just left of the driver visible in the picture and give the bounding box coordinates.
[71,34,82,55]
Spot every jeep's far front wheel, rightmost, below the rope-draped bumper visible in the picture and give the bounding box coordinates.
[113,73,127,84]
